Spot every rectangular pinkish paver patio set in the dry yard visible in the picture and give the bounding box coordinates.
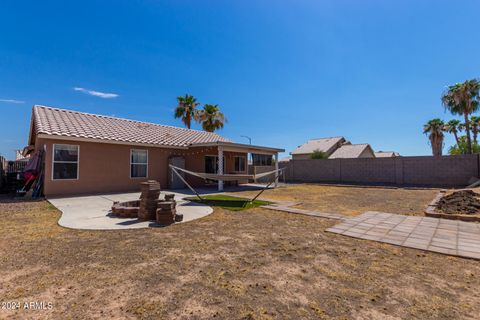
[326,212,480,259]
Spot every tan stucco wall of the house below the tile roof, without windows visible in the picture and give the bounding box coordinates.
[36,138,247,197]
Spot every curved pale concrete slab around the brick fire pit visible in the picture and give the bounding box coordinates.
[48,190,213,230]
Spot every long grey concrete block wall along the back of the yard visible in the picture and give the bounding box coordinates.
[280,154,480,187]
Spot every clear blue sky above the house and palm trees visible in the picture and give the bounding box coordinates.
[0,0,480,158]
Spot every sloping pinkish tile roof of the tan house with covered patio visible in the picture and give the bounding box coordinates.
[33,105,229,147]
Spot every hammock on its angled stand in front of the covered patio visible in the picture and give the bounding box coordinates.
[169,164,285,202]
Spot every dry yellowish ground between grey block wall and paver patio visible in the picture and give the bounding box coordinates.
[235,184,438,216]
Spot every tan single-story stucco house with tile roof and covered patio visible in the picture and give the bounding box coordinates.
[26,105,285,197]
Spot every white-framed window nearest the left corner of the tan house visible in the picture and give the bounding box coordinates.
[52,144,80,180]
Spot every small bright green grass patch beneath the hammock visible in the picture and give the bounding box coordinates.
[185,194,270,211]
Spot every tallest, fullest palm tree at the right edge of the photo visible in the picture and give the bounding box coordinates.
[442,79,480,153]
